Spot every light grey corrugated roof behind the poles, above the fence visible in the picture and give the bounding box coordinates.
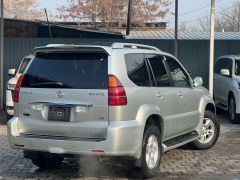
[125,31,240,40]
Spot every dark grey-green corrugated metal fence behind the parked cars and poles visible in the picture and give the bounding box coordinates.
[1,38,240,102]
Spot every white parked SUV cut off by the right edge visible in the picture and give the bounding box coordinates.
[214,55,240,123]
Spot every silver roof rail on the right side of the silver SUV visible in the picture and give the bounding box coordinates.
[111,43,161,51]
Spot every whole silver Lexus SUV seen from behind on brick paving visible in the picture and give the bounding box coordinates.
[8,43,220,178]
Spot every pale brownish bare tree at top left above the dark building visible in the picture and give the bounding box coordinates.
[4,0,44,19]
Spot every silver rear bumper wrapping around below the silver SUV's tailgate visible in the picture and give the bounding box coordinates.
[8,117,144,158]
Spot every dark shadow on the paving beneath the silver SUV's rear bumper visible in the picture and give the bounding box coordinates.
[35,157,146,179]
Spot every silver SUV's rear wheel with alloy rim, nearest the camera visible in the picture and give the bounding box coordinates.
[140,125,162,178]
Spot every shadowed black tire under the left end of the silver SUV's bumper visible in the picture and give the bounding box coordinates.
[29,152,64,169]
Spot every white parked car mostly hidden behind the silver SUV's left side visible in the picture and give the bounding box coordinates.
[6,54,33,116]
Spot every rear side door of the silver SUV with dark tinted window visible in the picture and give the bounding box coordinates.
[145,54,178,140]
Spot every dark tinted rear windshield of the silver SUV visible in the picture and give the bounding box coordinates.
[22,52,108,89]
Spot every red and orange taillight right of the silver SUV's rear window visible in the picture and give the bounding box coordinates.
[108,75,127,106]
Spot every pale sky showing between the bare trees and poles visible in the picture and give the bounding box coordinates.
[38,0,236,27]
